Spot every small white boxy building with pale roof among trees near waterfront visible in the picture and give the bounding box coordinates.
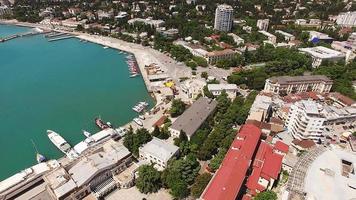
[139,137,179,170]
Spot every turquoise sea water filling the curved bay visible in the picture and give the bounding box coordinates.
[0,25,153,180]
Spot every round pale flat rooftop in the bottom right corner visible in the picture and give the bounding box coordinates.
[304,147,356,200]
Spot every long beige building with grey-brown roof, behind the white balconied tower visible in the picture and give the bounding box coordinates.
[264,75,333,94]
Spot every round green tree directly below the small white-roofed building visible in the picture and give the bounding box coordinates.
[136,165,162,194]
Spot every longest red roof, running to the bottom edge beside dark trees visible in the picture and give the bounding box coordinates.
[202,124,261,200]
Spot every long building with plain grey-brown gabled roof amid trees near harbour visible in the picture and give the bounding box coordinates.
[169,97,217,139]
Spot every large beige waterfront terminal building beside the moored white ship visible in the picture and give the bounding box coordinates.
[43,141,132,200]
